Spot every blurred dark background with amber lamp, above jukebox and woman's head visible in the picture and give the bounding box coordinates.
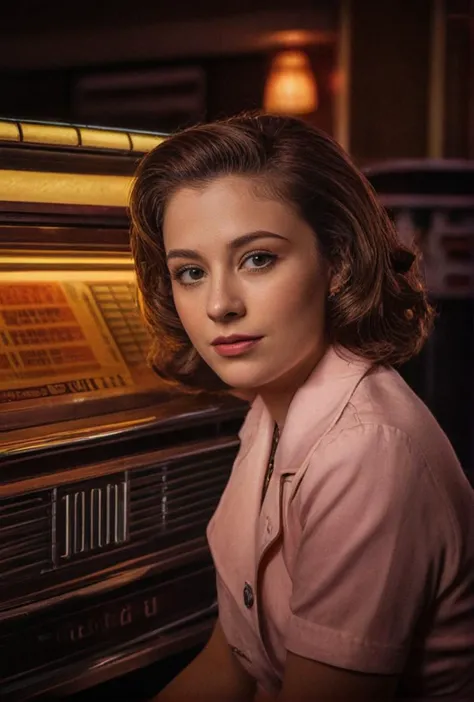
[0,0,474,164]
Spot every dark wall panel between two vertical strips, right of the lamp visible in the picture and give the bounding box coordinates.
[351,0,432,161]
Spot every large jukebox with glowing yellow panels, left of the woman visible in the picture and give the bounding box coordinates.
[0,120,245,702]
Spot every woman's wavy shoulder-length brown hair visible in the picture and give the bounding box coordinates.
[130,114,434,392]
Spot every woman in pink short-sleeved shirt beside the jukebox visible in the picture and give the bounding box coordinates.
[131,115,474,702]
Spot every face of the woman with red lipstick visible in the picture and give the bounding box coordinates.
[164,176,329,392]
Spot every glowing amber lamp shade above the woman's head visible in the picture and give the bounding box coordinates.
[263,50,318,115]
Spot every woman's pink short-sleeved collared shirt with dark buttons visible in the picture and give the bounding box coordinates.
[208,349,474,700]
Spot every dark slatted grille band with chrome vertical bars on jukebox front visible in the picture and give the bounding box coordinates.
[0,443,236,601]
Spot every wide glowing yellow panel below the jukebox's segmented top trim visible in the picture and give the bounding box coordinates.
[0,170,132,207]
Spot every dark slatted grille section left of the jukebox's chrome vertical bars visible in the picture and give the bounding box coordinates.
[0,491,51,583]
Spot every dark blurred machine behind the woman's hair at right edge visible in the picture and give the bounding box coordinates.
[366,159,474,483]
